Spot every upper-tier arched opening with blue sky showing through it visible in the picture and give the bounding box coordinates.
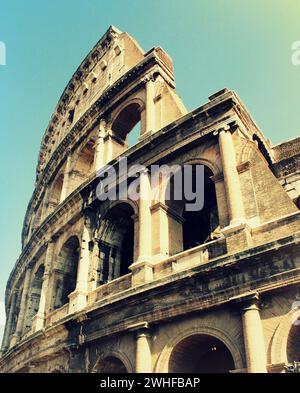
[112,103,141,147]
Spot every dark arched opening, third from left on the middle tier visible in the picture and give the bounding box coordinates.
[54,236,79,309]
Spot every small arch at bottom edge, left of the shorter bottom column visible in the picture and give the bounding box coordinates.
[91,350,134,373]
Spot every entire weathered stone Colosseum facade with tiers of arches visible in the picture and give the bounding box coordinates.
[0,26,300,373]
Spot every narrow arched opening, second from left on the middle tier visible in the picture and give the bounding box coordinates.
[25,265,45,331]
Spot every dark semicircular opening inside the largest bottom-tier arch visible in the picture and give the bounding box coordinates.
[169,334,235,373]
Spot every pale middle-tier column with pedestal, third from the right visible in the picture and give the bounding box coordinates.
[69,225,90,313]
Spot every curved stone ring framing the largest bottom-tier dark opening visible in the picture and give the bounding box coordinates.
[155,326,243,373]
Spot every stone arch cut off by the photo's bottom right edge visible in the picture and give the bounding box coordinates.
[270,308,300,364]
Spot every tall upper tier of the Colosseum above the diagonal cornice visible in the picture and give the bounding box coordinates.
[22,26,187,247]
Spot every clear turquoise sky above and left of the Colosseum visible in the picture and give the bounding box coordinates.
[0,0,300,335]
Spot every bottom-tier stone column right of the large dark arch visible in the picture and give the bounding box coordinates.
[242,294,267,373]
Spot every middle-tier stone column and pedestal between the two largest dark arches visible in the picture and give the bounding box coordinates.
[130,169,153,285]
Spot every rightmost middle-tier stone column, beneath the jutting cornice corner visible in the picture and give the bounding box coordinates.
[219,127,245,226]
